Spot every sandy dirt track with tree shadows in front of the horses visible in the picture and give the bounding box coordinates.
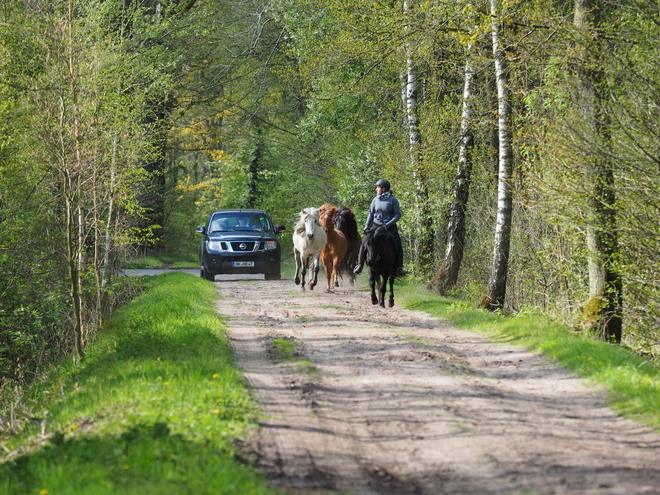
[216,280,660,495]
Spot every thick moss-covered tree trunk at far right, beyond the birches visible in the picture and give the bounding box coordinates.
[574,0,623,343]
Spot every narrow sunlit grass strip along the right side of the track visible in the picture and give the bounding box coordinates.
[396,283,660,431]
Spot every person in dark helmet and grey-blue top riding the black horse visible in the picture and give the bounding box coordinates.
[354,179,407,276]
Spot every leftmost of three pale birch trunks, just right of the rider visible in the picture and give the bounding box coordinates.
[403,0,435,273]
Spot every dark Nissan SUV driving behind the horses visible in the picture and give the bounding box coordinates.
[197,210,285,280]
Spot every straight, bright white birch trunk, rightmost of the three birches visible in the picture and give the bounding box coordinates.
[482,0,513,311]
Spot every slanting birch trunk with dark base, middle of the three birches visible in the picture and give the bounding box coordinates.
[433,36,474,294]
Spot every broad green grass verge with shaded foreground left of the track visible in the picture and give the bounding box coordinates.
[0,273,279,495]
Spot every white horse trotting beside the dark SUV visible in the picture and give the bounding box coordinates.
[293,208,326,290]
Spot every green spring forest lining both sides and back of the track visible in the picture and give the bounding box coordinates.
[0,0,660,396]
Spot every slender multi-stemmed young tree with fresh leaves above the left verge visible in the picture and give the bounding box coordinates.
[17,0,166,358]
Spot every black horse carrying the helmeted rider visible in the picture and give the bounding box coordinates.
[364,225,398,308]
